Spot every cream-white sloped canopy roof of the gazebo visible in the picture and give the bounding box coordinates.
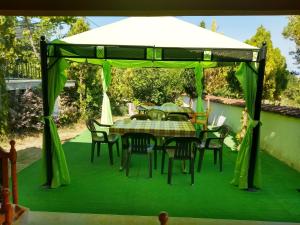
[62,17,258,50]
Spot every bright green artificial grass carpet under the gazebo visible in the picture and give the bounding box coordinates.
[18,129,300,222]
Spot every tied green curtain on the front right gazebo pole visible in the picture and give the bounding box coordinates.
[231,63,261,189]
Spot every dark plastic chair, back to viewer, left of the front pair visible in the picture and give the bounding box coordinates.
[122,133,156,177]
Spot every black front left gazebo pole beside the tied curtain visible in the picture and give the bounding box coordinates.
[40,36,53,187]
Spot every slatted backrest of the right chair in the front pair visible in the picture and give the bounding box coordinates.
[163,137,200,159]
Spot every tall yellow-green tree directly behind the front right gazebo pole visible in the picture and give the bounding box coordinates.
[246,26,288,100]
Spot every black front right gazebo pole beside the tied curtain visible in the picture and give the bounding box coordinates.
[248,42,267,191]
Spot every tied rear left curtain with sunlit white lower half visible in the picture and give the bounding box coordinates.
[101,61,113,125]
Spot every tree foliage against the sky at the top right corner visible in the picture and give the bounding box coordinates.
[282,15,300,68]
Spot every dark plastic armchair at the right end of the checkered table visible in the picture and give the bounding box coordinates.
[197,125,229,172]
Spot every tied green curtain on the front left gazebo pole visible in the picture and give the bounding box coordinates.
[42,49,70,188]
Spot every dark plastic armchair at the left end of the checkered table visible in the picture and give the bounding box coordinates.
[86,119,120,165]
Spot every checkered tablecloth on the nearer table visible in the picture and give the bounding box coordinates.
[109,119,196,137]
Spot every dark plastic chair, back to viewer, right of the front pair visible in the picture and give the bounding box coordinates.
[161,137,200,184]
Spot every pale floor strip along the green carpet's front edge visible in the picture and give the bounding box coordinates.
[28,212,299,225]
